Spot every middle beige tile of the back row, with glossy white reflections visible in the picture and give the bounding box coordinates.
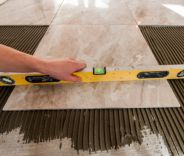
[53,0,136,25]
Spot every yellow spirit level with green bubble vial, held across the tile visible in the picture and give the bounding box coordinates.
[0,65,184,86]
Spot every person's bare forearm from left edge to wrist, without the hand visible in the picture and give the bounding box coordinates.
[0,45,44,72]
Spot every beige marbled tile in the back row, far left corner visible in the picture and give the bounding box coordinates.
[0,0,63,25]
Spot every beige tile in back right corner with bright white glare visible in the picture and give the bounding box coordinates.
[124,0,184,25]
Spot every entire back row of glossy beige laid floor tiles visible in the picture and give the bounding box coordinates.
[0,0,184,25]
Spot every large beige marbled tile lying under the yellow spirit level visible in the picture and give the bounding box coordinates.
[4,25,180,110]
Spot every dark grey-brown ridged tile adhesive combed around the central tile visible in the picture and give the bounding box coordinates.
[0,26,184,155]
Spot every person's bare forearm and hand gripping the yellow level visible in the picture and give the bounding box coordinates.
[0,45,86,81]
